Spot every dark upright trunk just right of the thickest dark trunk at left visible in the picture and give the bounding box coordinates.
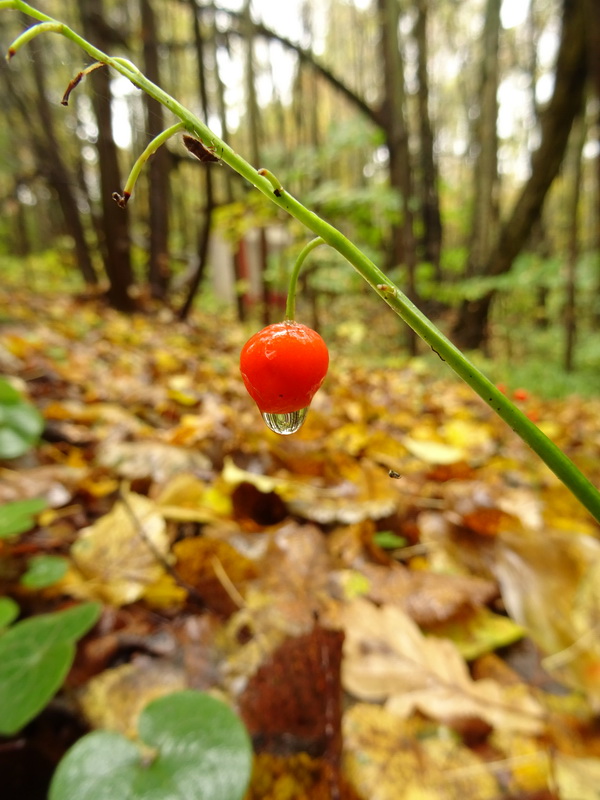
[140,0,171,300]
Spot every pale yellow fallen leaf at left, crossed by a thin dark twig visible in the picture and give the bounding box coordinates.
[61,493,169,606]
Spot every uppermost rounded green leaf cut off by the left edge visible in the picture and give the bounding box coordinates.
[0,378,44,458]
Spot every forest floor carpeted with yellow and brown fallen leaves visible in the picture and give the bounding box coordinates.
[0,290,600,800]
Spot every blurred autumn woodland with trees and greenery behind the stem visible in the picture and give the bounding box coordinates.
[0,0,600,396]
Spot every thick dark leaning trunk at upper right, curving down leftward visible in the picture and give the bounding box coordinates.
[453,0,586,349]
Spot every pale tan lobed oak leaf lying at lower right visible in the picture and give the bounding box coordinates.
[342,598,544,734]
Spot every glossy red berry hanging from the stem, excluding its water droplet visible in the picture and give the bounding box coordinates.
[240,321,329,414]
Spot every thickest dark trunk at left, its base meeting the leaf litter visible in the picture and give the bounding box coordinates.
[79,0,134,311]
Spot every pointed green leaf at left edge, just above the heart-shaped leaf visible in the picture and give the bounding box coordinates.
[0,603,101,736]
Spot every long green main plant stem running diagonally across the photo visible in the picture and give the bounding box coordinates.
[0,0,600,522]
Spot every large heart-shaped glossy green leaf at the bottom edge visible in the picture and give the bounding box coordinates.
[49,690,252,800]
